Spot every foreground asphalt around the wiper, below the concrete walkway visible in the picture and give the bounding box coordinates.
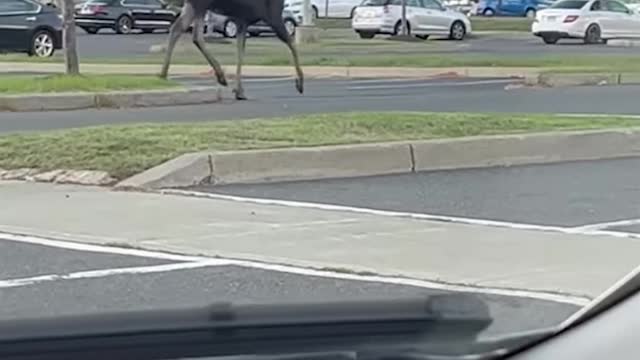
[0,234,577,336]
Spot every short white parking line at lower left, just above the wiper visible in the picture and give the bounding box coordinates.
[0,259,230,289]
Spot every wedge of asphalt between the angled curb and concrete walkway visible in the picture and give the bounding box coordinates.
[192,158,640,228]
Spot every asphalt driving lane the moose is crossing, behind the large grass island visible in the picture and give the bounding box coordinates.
[0,76,640,133]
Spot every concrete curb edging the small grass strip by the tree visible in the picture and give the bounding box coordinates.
[0,87,222,111]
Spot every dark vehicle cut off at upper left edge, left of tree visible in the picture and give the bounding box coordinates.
[0,0,62,57]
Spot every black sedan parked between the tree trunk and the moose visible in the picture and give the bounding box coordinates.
[74,0,178,34]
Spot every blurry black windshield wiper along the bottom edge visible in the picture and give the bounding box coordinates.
[0,294,492,360]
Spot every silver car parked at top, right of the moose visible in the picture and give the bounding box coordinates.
[351,0,471,40]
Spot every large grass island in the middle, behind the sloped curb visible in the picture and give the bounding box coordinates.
[0,112,638,179]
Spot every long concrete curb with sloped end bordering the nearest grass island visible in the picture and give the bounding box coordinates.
[116,128,640,189]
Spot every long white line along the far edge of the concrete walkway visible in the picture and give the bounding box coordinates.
[160,189,640,239]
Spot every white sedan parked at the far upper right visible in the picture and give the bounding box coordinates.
[531,0,640,44]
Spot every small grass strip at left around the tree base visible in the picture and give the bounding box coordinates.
[0,74,179,94]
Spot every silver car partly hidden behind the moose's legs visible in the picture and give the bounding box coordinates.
[205,10,302,38]
